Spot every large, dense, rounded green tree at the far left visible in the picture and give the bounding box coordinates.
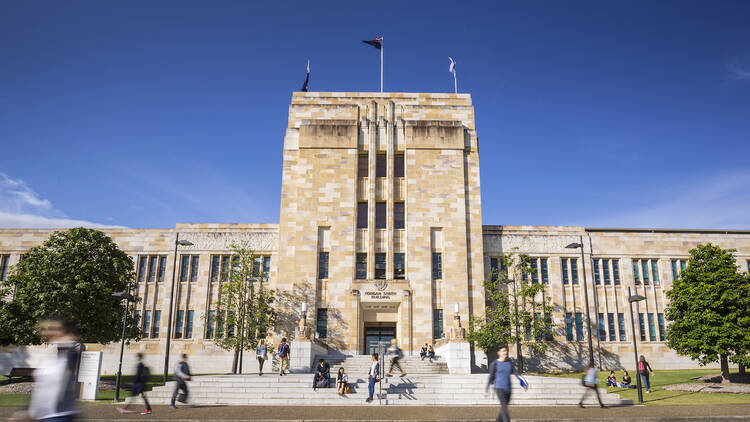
[0,228,139,345]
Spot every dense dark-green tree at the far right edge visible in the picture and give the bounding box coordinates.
[666,243,750,382]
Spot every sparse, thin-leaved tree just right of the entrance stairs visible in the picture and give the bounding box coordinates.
[467,249,555,364]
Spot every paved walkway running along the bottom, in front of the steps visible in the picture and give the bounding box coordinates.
[0,404,750,422]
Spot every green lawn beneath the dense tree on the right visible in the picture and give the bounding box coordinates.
[554,369,750,405]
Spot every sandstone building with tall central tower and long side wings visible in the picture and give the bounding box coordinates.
[0,92,750,372]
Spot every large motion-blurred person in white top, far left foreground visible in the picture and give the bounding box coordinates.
[14,317,81,422]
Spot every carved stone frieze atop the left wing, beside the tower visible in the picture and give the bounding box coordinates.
[180,232,279,251]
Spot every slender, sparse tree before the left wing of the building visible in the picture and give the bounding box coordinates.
[204,243,276,373]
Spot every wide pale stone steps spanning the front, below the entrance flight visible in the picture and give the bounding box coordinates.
[148,370,632,406]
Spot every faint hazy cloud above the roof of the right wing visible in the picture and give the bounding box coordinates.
[586,171,750,230]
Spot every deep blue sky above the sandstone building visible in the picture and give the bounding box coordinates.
[0,0,750,229]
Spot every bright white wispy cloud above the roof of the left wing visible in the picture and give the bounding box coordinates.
[0,172,123,228]
